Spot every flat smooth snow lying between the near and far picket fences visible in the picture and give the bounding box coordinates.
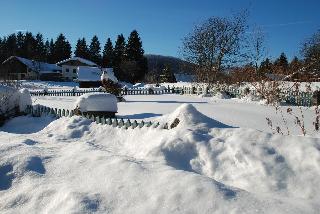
[33,95,315,135]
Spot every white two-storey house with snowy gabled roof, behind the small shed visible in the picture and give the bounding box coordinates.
[57,57,98,81]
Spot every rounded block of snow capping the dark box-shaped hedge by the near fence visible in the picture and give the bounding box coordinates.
[74,93,118,112]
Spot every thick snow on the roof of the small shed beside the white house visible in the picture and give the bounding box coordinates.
[78,66,118,82]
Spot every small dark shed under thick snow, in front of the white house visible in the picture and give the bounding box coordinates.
[77,66,118,88]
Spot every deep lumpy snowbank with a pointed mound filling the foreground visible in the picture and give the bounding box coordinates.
[0,104,320,213]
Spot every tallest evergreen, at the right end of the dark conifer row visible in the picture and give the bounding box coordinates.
[126,30,144,61]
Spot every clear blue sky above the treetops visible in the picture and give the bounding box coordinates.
[0,0,320,58]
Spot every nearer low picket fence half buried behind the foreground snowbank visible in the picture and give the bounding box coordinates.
[26,105,169,129]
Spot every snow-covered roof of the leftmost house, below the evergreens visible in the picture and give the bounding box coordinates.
[3,56,62,73]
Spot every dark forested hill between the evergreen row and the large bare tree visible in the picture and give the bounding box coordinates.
[145,54,193,74]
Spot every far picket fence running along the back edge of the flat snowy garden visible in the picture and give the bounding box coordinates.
[30,86,313,107]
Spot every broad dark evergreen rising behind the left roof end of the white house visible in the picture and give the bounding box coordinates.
[52,33,71,63]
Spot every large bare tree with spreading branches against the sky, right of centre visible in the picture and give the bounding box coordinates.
[182,11,247,85]
